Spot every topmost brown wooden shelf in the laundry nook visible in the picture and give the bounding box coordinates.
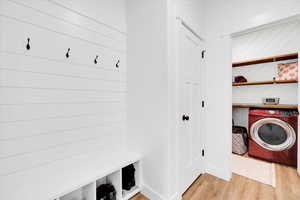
[232,53,298,67]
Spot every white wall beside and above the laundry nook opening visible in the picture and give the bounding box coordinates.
[205,0,300,179]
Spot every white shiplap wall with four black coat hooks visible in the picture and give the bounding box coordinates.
[0,0,126,179]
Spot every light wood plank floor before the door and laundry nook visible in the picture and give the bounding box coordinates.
[131,165,300,200]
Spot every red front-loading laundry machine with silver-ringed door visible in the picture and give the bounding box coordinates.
[248,109,299,166]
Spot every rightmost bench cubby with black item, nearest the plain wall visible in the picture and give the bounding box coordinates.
[122,161,141,200]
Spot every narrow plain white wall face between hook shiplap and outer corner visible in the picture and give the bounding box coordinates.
[127,0,168,198]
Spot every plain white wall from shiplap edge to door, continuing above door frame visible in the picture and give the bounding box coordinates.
[127,0,204,199]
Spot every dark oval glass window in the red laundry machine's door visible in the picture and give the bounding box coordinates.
[257,123,288,145]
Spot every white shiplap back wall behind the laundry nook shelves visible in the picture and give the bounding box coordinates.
[232,21,300,127]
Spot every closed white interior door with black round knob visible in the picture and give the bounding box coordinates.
[177,22,203,194]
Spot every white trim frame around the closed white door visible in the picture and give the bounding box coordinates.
[174,17,206,196]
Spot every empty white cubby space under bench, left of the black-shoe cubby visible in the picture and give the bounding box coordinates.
[59,183,96,200]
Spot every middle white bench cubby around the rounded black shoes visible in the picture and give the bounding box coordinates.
[96,170,122,200]
